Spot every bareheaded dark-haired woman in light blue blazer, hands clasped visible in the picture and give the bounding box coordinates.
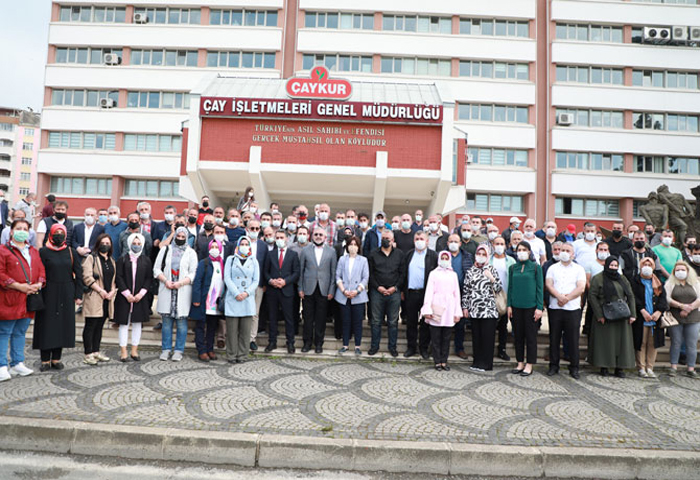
[335,236,369,355]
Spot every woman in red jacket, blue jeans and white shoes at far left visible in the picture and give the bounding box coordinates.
[0,219,46,382]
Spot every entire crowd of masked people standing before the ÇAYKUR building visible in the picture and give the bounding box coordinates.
[0,187,700,381]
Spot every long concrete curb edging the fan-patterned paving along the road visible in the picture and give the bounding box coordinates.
[0,417,700,480]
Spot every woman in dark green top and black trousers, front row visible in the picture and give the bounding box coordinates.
[508,240,544,377]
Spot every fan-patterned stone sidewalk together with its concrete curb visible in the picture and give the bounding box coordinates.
[0,349,700,479]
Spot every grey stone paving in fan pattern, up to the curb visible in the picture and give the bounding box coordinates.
[0,350,700,451]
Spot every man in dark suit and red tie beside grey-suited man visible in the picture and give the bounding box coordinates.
[263,229,299,353]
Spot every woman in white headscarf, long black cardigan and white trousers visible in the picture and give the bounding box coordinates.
[114,233,153,362]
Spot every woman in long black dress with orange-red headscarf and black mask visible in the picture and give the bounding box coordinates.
[32,223,83,372]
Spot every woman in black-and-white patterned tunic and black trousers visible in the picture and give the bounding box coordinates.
[462,244,503,372]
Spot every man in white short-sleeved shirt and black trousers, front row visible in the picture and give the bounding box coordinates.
[545,243,586,380]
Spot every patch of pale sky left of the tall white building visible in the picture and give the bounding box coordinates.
[0,0,51,111]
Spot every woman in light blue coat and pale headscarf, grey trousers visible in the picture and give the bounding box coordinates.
[224,235,260,363]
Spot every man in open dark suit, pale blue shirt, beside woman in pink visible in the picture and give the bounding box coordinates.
[401,230,438,358]
